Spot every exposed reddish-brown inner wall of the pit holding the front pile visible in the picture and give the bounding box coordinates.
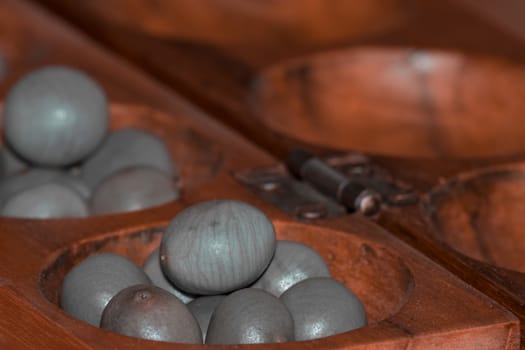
[39,222,413,324]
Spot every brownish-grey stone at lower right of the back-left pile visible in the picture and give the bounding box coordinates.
[90,167,179,215]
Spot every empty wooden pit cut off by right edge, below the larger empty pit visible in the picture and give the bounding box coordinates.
[428,166,525,272]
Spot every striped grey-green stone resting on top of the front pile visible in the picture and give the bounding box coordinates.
[160,200,275,295]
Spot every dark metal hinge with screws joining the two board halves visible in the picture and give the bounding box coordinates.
[233,150,419,221]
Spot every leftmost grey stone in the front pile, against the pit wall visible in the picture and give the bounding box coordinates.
[60,253,150,327]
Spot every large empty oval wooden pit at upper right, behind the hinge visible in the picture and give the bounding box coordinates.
[251,47,525,158]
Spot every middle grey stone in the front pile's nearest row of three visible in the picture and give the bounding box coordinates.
[206,288,294,344]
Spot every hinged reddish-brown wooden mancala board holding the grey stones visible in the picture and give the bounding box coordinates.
[0,0,525,349]
